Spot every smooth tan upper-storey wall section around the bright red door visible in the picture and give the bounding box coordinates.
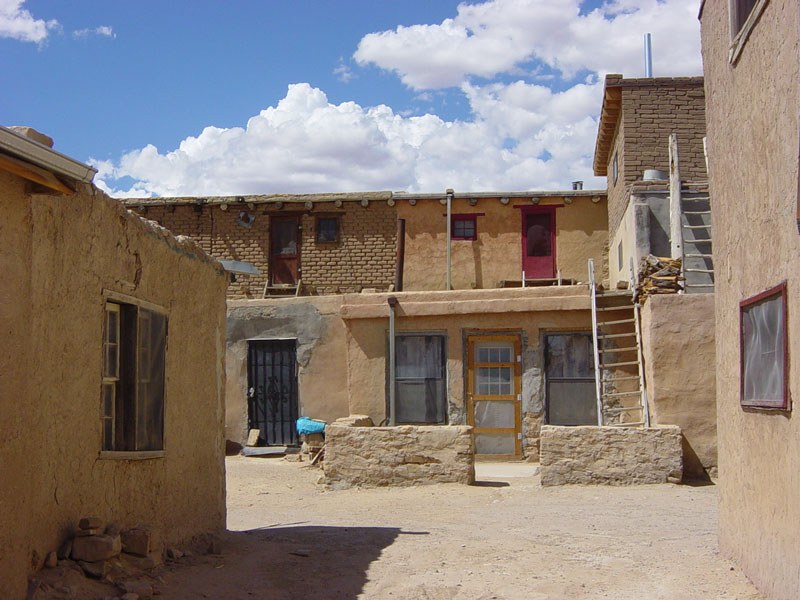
[396,196,608,291]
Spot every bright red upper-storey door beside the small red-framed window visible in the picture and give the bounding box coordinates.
[522,206,556,279]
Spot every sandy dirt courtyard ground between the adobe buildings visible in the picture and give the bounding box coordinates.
[148,457,762,600]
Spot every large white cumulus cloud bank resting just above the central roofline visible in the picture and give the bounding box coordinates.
[92,82,601,197]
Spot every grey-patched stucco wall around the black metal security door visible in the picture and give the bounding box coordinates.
[225,295,349,444]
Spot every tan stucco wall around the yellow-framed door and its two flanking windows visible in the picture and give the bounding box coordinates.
[342,286,591,458]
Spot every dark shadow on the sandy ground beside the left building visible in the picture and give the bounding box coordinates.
[155,525,418,600]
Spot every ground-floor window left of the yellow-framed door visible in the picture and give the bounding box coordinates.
[395,334,447,425]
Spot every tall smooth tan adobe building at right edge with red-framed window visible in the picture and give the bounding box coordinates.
[700,0,800,600]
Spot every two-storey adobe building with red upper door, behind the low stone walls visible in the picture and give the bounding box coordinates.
[126,190,608,459]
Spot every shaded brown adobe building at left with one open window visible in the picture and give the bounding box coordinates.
[0,128,227,599]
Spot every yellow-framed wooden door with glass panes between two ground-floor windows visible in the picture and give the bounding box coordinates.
[467,335,522,458]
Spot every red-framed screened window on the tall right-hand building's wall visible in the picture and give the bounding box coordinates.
[739,282,789,410]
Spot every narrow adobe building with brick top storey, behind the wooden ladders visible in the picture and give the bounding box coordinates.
[594,74,717,477]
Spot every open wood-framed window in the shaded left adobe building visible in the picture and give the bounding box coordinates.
[101,299,167,452]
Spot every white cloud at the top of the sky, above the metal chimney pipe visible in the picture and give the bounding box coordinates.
[354,0,701,90]
